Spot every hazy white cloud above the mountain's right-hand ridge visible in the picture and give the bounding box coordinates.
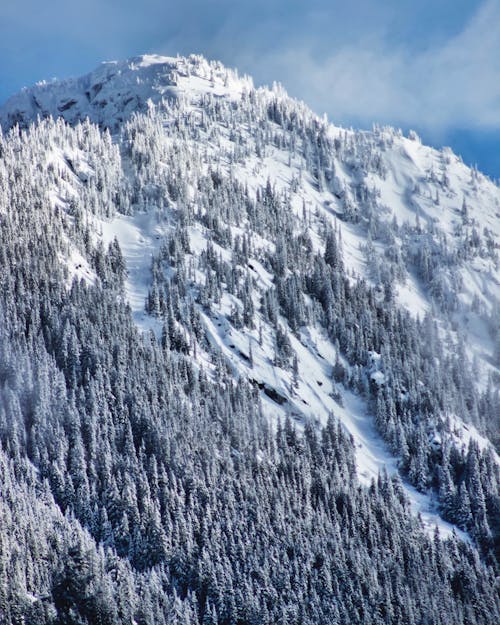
[260,0,500,132]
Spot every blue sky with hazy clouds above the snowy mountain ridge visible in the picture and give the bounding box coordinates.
[0,0,500,178]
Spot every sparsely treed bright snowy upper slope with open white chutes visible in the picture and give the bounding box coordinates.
[0,56,500,532]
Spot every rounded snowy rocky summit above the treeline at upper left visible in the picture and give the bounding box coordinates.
[0,54,252,130]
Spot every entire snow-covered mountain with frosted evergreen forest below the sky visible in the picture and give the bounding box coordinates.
[0,56,500,624]
